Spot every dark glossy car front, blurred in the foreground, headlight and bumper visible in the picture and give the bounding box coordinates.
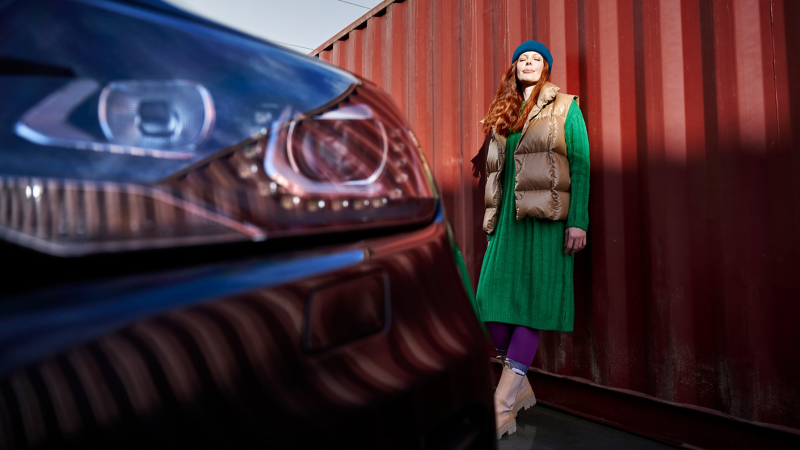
[0,0,495,448]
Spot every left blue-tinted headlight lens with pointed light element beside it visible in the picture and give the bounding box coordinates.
[15,79,216,159]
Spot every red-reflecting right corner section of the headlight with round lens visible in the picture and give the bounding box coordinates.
[162,84,436,243]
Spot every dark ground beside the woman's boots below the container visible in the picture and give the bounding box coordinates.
[497,405,674,450]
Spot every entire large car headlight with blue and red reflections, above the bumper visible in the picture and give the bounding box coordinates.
[0,0,436,256]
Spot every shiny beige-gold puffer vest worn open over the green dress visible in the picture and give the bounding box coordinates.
[483,82,578,234]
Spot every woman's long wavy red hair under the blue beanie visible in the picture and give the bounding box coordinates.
[483,61,550,137]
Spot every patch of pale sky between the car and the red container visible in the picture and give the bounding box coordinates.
[165,0,381,54]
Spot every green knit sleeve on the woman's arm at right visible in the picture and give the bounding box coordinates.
[564,100,589,231]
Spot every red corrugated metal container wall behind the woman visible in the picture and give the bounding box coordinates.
[314,0,800,429]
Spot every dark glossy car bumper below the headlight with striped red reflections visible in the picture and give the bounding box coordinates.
[0,217,495,448]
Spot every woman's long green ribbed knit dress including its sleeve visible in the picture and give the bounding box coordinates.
[476,101,589,331]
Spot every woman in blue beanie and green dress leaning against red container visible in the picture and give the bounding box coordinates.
[477,41,589,439]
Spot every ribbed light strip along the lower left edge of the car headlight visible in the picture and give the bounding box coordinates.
[0,177,266,256]
